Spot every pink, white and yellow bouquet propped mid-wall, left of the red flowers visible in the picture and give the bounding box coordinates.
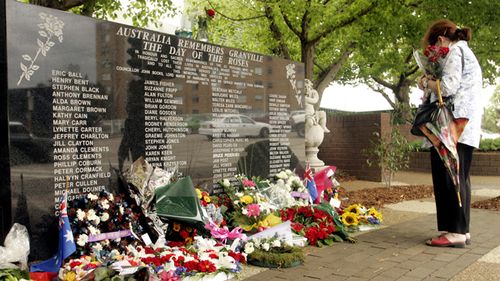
[220,176,281,232]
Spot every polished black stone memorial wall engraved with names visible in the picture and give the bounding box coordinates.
[0,0,305,258]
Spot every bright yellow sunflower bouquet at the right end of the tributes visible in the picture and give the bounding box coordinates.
[340,204,382,231]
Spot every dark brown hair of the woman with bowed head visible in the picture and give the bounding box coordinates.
[422,19,472,48]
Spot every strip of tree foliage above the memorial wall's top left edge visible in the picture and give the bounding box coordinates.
[23,0,179,26]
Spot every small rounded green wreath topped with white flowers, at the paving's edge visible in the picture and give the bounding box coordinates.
[244,236,304,268]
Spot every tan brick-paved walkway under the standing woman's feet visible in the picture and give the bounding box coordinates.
[240,170,500,281]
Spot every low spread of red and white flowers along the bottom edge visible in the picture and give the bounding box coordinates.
[59,236,246,281]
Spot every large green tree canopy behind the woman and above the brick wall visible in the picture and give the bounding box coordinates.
[189,0,500,119]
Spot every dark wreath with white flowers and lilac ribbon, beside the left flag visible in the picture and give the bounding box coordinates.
[68,191,145,257]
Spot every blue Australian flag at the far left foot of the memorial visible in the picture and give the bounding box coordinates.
[30,193,76,272]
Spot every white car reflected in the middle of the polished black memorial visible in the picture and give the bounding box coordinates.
[198,114,271,140]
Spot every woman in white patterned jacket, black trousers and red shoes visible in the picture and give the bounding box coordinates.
[419,19,483,247]
